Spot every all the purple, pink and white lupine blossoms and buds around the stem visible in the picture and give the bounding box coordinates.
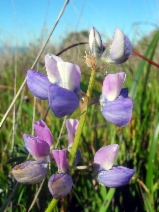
[12,28,134,199]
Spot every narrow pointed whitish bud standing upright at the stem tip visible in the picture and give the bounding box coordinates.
[89,27,103,58]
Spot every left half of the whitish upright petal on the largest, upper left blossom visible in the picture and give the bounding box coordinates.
[45,54,63,86]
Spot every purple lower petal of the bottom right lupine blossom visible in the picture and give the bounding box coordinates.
[98,166,134,188]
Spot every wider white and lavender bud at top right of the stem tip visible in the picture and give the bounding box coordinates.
[108,28,132,64]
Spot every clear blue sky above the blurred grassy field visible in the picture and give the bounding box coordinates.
[0,0,159,46]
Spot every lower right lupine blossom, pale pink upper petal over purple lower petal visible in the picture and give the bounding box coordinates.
[93,144,134,188]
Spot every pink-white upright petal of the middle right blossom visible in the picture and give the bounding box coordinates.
[102,72,126,101]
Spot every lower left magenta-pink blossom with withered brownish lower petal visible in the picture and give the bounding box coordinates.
[12,120,53,184]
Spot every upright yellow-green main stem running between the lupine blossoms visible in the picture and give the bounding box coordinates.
[69,69,96,167]
